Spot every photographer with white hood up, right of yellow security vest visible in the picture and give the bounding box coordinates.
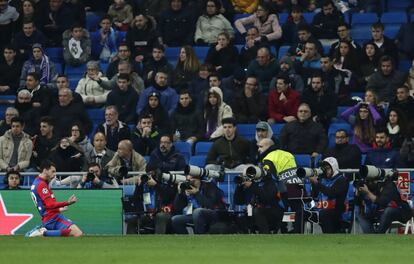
[305,157,348,233]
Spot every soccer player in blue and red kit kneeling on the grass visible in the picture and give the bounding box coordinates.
[26,160,82,237]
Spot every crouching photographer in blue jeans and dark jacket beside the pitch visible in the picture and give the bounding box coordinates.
[171,176,225,234]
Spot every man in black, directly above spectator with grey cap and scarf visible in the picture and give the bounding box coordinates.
[13,20,47,60]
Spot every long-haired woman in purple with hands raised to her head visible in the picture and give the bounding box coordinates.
[341,103,381,153]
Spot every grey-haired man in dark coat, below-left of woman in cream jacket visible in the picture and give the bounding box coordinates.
[49,88,92,138]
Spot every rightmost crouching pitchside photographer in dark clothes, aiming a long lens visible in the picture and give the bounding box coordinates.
[355,168,412,233]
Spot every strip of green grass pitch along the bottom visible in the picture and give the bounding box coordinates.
[0,235,414,264]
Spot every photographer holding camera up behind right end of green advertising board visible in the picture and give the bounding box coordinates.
[77,162,119,189]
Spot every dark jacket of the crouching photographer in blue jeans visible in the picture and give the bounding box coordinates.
[174,182,226,214]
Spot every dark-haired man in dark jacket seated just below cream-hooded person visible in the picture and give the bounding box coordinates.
[206,117,251,171]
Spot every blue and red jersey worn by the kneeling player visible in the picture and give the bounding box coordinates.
[30,177,69,223]
